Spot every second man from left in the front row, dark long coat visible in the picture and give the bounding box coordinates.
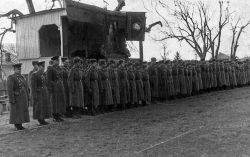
[31,61,52,125]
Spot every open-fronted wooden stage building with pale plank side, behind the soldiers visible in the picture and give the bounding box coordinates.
[15,0,146,74]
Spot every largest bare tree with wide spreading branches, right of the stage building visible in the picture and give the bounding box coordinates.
[155,0,230,60]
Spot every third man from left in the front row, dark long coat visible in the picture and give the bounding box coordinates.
[47,56,66,122]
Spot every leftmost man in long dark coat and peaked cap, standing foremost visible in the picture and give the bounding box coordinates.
[7,63,30,130]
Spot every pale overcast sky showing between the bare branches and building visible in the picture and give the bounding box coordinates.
[0,0,250,60]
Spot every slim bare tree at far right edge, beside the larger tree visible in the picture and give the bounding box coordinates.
[230,18,250,60]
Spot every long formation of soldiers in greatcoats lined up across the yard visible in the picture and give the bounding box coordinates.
[7,56,250,130]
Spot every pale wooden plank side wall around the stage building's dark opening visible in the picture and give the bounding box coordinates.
[16,10,66,59]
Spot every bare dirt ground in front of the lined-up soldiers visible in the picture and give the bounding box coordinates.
[0,87,250,157]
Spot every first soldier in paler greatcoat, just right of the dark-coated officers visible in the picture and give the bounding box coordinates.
[68,57,84,114]
